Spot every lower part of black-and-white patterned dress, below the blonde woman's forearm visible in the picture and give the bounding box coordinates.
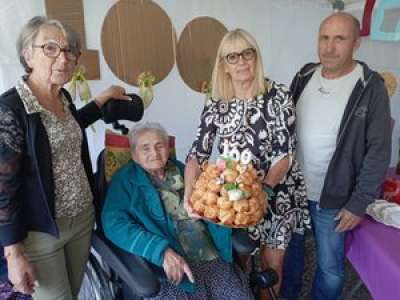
[247,161,311,250]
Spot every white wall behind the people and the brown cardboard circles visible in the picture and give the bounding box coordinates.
[0,0,400,166]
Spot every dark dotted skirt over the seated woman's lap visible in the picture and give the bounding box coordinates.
[150,259,252,300]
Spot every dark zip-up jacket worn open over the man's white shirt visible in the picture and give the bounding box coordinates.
[290,62,392,216]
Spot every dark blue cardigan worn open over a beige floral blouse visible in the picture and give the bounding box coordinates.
[0,88,102,246]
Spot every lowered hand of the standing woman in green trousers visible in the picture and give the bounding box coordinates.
[4,244,37,295]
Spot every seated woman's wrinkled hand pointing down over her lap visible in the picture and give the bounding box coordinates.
[163,248,194,285]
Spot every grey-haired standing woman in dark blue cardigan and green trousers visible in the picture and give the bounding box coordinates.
[0,17,128,300]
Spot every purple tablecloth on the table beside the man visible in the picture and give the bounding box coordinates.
[346,217,400,300]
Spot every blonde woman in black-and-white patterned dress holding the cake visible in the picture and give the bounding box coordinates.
[185,29,310,298]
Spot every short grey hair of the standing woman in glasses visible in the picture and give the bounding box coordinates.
[17,16,82,74]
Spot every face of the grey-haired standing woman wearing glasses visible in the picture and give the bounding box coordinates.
[24,26,77,86]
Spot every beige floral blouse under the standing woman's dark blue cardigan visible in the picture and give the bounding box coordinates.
[16,81,93,218]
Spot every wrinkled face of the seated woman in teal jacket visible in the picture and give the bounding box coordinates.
[132,130,169,175]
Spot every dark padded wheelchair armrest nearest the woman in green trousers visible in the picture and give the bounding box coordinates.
[92,232,160,297]
